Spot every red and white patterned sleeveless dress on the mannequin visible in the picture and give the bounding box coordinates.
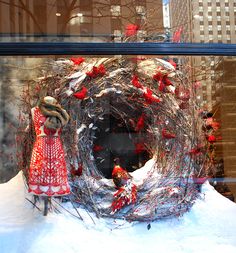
[29,107,70,196]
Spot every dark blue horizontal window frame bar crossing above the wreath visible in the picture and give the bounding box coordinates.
[0,42,236,56]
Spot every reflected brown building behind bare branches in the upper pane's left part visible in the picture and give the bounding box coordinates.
[0,0,163,41]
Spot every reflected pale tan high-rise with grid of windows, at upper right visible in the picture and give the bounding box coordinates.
[170,0,236,110]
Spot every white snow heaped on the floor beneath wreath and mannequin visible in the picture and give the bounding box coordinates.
[0,173,236,253]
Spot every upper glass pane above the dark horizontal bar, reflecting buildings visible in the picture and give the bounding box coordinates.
[0,0,236,43]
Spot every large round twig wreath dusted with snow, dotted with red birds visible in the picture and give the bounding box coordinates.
[20,56,214,221]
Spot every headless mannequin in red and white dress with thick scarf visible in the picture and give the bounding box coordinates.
[29,96,70,215]
